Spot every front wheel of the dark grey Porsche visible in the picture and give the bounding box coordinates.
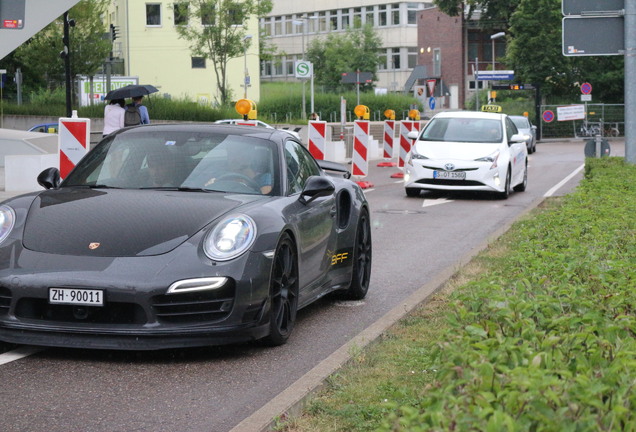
[265,234,298,346]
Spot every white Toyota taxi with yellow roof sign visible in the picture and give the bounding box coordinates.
[404,111,528,199]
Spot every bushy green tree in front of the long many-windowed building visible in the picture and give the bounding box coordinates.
[307,24,382,87]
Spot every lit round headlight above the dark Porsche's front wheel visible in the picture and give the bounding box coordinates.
[203,215,256,261]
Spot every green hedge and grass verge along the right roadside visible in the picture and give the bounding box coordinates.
[278,158,636,432]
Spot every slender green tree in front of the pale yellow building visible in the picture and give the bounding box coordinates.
[175,0,272,105]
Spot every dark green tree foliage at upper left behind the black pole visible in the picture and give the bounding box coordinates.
[12,0,111,91]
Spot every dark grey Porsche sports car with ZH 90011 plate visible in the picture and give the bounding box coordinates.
[0,124,371,350]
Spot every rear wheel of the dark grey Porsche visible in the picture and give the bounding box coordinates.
[342,209,372,300]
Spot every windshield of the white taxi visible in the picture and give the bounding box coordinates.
[419,117,503,143]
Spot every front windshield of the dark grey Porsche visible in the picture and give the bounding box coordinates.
[62,130,279,194]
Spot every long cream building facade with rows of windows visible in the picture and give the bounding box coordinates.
[260,0,432,91]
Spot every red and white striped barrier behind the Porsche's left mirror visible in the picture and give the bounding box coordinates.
[58,112,91,178]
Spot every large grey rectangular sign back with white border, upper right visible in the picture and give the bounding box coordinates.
[562,16,625,57]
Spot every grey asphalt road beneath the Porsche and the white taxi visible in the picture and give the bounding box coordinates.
[0,141,623,432]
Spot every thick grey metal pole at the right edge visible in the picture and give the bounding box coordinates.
[624,0,636,164]
